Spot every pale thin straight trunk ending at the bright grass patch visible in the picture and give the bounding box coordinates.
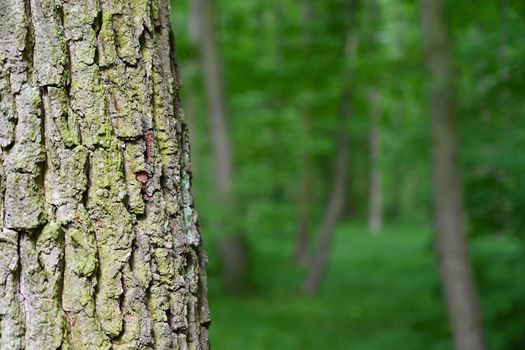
[368,88,383,233]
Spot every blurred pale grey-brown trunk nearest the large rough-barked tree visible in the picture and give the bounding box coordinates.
[193,0,247,290]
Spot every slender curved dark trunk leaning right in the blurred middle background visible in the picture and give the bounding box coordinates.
[302,0,358,295]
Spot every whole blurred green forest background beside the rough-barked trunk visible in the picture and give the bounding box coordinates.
[172,0,525,350]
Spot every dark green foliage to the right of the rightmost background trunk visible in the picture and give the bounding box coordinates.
[453,1,525,236]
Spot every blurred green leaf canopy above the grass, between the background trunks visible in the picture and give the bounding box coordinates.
[173,0,525,235]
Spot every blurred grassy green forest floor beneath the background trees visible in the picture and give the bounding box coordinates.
[204,224,525,350]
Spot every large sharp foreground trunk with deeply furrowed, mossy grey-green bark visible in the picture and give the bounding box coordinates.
[0,0,210,350]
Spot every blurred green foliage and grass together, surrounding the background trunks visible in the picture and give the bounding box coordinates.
[173,0,525,350]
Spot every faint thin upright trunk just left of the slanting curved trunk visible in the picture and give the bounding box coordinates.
[294,0,313,267]
